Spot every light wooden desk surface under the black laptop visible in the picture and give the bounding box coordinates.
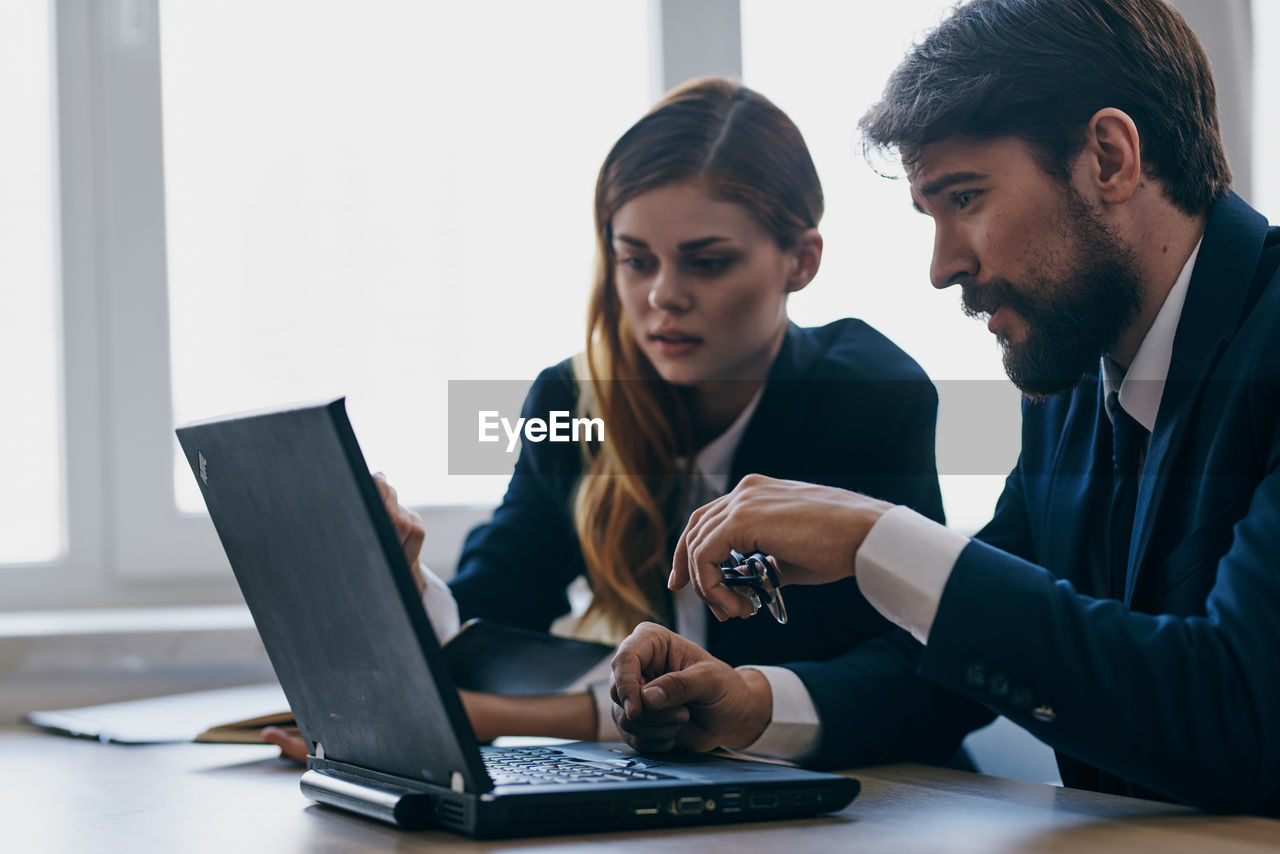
[0,727,1280,854]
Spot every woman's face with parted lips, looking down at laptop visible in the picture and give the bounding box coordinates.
[612,182,822,385]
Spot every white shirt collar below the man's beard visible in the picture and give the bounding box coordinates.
[1102,238,1203,433]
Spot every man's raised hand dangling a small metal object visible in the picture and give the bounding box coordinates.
[668,475,892,620]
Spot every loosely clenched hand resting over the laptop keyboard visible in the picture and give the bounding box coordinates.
[609,622,773,750]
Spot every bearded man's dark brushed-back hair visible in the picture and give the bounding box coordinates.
[859,0,1231,215]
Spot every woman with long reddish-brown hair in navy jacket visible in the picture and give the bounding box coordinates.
[270,78,942,763]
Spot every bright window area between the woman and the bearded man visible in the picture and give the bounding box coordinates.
[742,0,1019,530]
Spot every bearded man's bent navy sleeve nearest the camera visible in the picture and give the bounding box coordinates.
[920,465,1280,810]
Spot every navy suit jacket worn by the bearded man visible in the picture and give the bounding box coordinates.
[901,195,1280,816]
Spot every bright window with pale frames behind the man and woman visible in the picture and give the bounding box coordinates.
[0,0,1280,608]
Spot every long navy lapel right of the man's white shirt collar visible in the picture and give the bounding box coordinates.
[1124,192,1267,606]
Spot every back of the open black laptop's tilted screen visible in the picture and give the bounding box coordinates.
[177,399,492,791]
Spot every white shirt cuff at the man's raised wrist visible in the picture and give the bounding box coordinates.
[854,507,969,644]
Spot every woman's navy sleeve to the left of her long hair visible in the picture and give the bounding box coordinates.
[449,365,584,631]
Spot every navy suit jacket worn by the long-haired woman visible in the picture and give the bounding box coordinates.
[451,320,955,696]
